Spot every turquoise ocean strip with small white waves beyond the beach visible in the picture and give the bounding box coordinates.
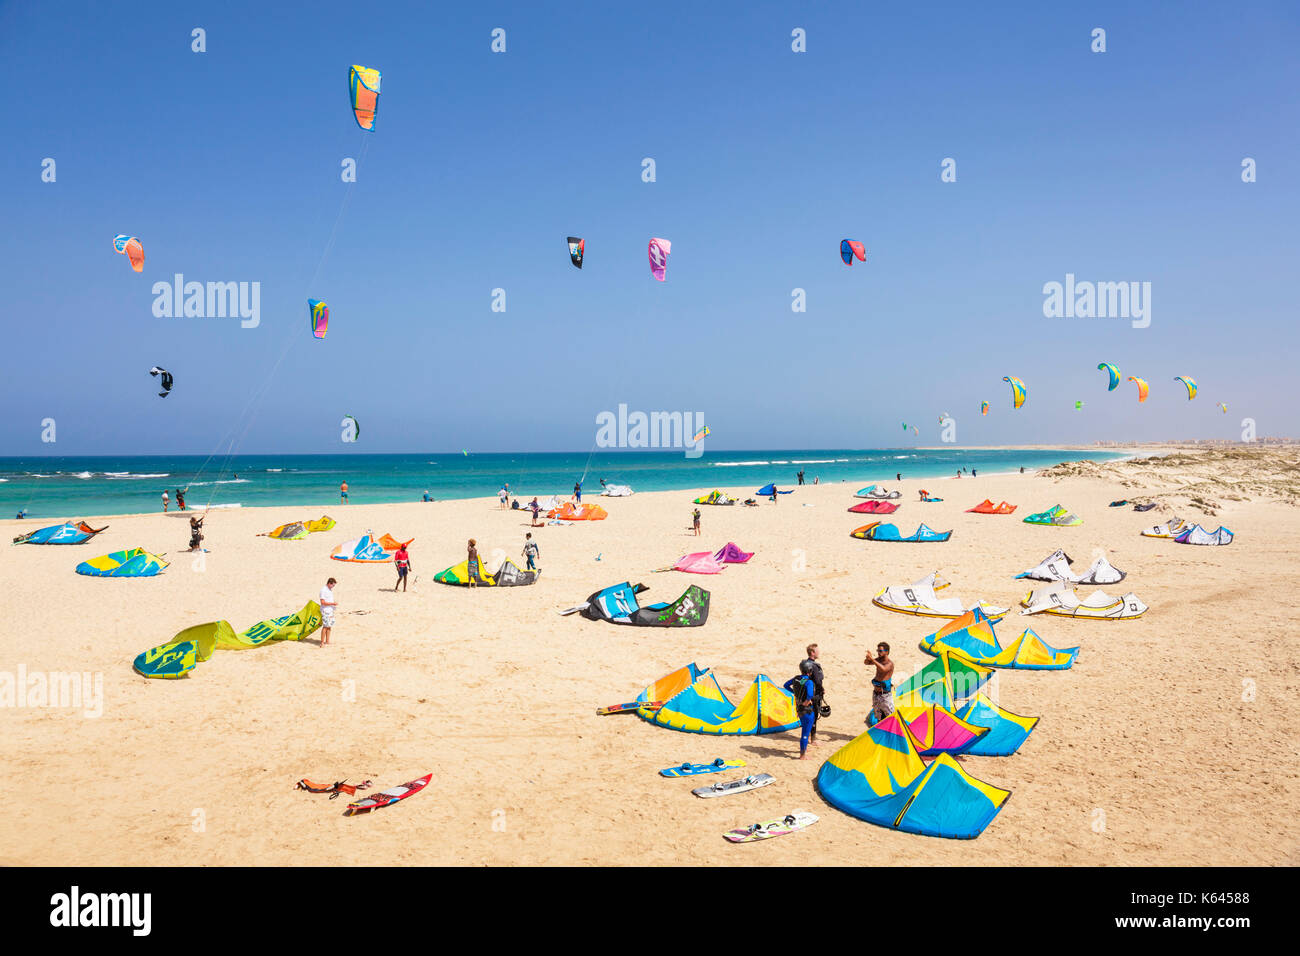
[0,449,1123,519]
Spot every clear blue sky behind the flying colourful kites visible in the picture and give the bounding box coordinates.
[0,3,1300,455]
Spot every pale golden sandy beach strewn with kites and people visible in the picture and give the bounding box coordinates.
[0,446,1300,866]
